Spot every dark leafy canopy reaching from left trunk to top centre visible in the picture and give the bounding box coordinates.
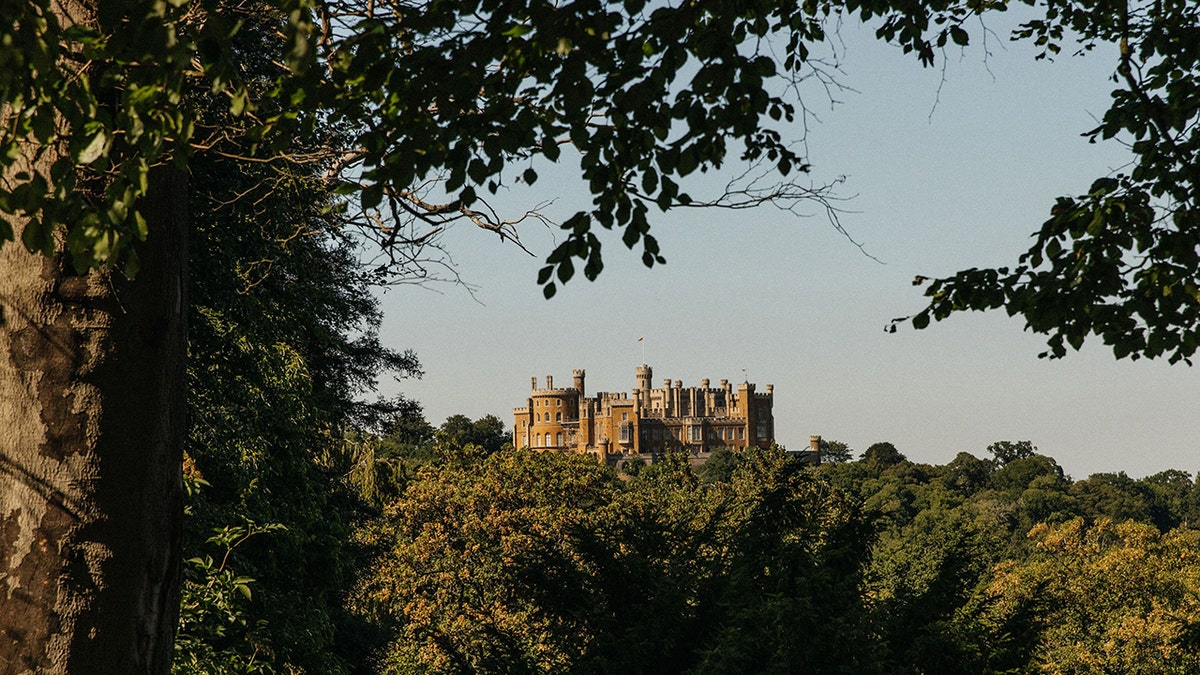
[0,0,1080,295]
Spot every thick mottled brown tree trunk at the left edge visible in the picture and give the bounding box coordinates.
[0,168,187,674]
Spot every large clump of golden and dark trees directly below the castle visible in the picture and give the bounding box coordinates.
[354,449,869,673]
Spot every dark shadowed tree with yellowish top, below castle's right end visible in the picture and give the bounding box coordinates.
[690,448,880,673]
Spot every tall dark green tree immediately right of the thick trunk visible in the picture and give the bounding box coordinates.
[176,13,420,673]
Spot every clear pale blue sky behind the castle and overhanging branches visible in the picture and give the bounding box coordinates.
[380,14,1200,478]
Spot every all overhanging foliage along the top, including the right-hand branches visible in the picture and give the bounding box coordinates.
[9,0,1200,362]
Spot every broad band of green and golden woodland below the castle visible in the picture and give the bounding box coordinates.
[326,442,1200,673]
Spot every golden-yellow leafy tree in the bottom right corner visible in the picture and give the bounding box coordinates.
[979,519,1200,674]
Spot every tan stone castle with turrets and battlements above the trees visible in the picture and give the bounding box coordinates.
[512,364,775,461]
